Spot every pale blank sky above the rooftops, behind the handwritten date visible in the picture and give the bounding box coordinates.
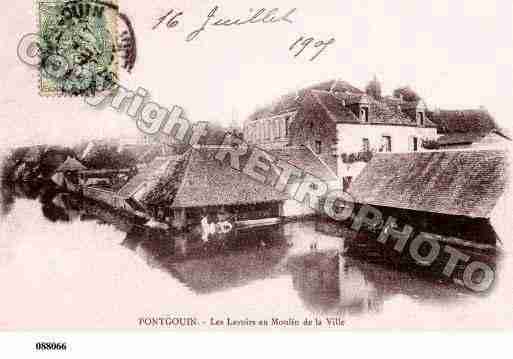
[0,0,513,146]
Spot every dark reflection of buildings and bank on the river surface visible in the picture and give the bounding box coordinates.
[0,183,488,315]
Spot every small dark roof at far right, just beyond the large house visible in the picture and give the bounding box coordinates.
[428,110,499,134]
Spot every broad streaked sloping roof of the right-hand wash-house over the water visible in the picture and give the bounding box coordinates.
[349,150,507,218]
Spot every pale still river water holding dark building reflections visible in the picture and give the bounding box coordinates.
[0,181,513,329]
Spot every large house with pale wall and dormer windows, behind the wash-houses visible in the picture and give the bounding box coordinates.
[243,79,437,186]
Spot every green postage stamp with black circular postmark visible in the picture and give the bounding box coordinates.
[37,0,118,96]
